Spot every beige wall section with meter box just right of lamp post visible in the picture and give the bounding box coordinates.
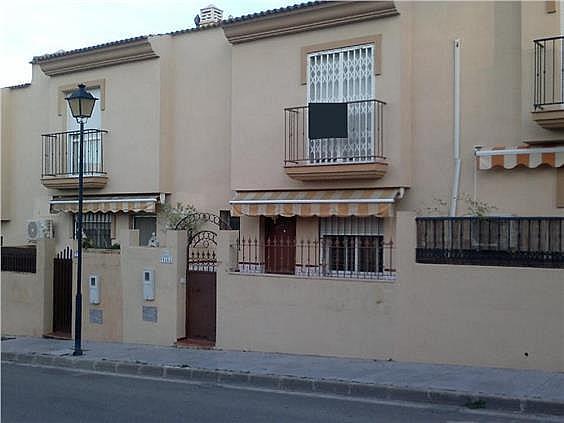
[82,250,123,341]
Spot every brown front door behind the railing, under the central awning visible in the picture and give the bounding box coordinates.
[264,217,296,275]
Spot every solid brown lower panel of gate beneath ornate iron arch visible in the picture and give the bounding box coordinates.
[186,270,216,342]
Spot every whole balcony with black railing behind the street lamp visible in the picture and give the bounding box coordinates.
[41,129,108,189]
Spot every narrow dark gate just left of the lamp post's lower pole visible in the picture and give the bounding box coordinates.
[53,247,72,337]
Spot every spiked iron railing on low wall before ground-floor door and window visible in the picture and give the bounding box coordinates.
[233,235,396,280]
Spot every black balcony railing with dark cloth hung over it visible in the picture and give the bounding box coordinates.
[284,100,386,166]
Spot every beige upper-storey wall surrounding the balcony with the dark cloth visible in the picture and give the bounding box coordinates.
[231,13,410,190]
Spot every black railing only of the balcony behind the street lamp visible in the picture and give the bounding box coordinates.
[41,129,107,177]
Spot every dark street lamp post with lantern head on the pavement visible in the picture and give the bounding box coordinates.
[65,84,98,355]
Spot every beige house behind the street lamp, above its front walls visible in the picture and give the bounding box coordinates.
[2,27,231,250]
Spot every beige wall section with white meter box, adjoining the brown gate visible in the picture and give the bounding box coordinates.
[120,230,186,345]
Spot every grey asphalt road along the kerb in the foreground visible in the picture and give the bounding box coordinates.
[1,363,556,423]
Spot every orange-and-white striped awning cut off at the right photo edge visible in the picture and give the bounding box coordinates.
[476,145,564,170]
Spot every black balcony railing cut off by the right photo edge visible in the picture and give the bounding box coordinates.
[533,36,564,110]
